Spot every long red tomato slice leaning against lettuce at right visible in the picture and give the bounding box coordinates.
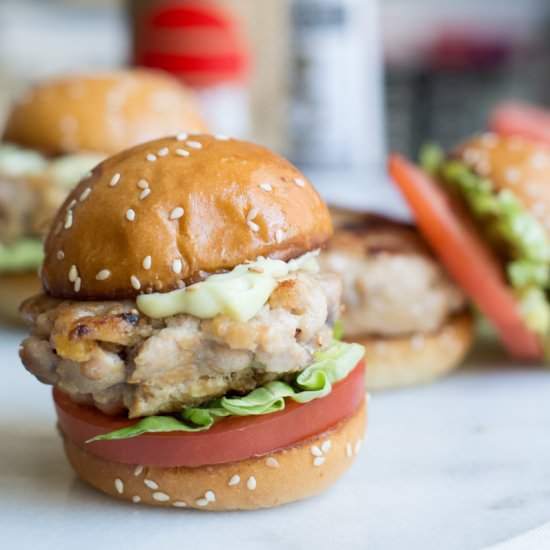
[389,154,543,360]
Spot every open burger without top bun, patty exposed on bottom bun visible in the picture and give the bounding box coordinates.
[321,211,472,389]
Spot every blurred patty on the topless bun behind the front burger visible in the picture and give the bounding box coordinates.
[320,217,466,337]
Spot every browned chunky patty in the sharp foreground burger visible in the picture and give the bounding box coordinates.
[20,271,341,418]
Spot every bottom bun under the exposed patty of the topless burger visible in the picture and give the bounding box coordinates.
[353,312,473,390]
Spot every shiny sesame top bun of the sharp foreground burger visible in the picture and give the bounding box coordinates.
[42,134,332,300]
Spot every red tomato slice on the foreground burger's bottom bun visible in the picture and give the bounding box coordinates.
[53,362,365,467]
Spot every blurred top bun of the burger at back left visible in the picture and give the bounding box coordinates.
[3,69,207,155]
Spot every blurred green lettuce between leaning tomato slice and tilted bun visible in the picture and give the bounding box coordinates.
[421,145,550,336]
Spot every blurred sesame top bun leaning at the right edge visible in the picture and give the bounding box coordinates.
[453,133,550,230]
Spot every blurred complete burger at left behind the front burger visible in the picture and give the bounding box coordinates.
[0,70,205,321]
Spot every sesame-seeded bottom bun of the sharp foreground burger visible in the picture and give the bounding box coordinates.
[64,401,366,511]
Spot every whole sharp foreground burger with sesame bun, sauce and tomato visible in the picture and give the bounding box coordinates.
[20,134,365,510]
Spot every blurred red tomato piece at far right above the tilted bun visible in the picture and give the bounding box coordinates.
[489,102,550,145]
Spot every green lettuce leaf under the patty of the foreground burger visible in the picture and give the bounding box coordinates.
[88,341,364,443]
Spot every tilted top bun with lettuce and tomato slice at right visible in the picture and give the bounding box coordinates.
[390,133,550,361]
